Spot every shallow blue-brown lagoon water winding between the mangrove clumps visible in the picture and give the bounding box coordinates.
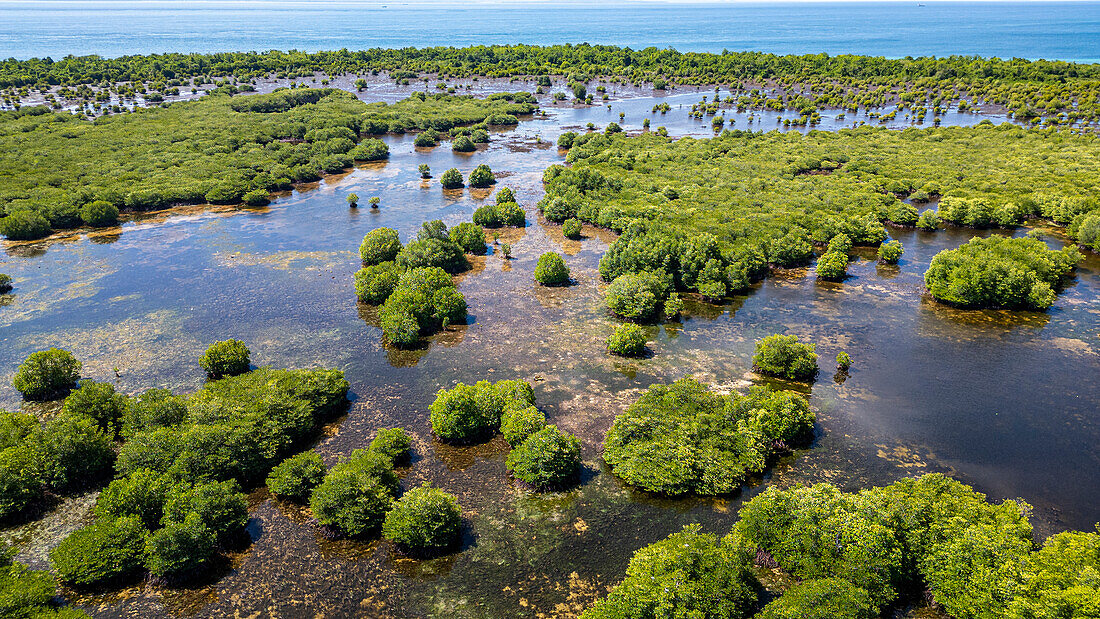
[0,92,1100,617]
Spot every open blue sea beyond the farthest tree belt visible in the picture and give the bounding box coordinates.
[0,0,1100,62]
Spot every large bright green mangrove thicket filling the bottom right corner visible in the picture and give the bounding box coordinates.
[583,475,1100,619]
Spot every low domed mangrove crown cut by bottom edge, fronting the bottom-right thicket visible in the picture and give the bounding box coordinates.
[758,578,877,619]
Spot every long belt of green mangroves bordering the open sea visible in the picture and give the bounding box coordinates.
[0,44,1100,121]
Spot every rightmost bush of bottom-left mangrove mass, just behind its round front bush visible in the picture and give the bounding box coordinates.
[163,479,249,543]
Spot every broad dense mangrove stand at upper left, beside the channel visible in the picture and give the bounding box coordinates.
[0,89,535,239]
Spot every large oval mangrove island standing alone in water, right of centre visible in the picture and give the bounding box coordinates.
[604,378,814,495]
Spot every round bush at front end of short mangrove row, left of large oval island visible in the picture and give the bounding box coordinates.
[506,425,581,490]
